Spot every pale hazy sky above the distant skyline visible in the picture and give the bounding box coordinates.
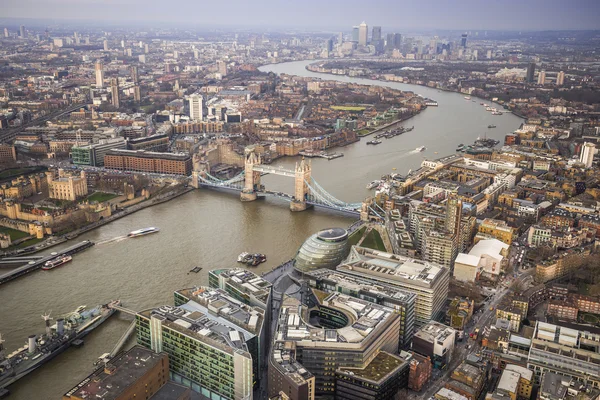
[0,0,600,30]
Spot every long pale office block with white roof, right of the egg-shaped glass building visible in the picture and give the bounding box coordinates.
[336,246,450,327]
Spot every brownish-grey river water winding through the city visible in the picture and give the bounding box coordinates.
[0,57,521,400]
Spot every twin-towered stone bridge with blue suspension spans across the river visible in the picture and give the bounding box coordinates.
[192,151,362,215]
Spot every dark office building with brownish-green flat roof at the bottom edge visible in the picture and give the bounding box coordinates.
[335,351,410,400]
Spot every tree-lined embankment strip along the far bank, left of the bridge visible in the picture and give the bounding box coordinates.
[0,187,194,256]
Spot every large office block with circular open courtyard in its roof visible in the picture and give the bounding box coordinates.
[268,289,400,400]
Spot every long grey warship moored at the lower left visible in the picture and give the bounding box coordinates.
[0,300,121,390]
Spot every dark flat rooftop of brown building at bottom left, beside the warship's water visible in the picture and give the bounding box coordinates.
[65,346,166,400]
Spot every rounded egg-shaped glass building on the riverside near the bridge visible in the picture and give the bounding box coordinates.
[294,228,350,272]
